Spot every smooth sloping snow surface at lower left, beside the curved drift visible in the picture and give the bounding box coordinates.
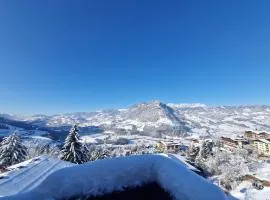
[0,156,74,197]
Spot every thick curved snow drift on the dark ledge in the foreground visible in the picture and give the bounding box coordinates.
[3,155,227,200]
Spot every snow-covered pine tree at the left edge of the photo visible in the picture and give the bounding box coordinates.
[0,133,27,167]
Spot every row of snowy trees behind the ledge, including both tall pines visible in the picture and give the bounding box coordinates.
[0,125,157,168]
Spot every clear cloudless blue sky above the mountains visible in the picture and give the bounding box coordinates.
[0,0,270,114]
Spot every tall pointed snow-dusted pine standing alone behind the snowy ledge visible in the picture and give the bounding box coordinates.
[60,125,87,164]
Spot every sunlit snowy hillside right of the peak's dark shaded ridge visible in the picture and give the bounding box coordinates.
[171,105,270,136]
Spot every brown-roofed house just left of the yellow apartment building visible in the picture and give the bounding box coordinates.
[221,137,248,152]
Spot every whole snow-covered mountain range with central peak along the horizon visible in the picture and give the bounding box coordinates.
[2,101,270,136]
